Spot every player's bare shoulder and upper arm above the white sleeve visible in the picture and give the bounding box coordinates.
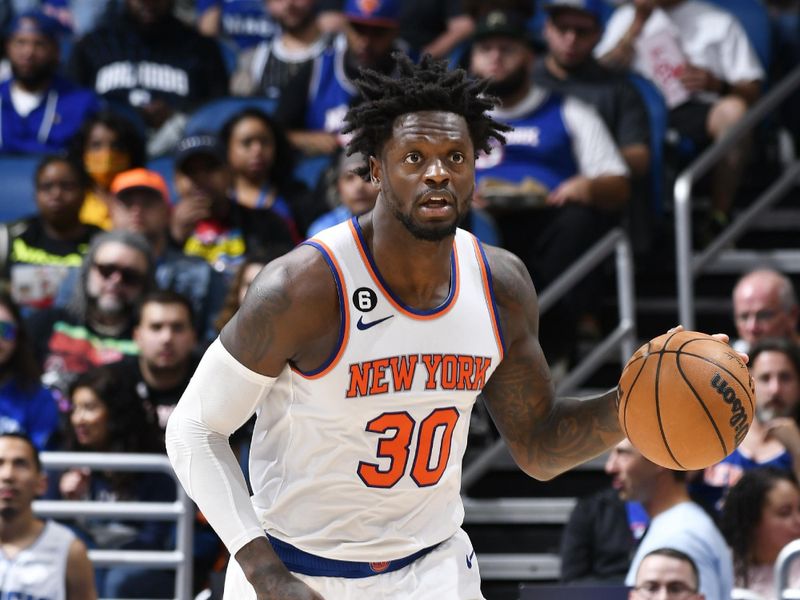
[221,245,339,376]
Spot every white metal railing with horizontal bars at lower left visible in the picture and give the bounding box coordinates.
[33,452,194,600]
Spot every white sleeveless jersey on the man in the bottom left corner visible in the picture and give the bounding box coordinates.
[0,521,75,600]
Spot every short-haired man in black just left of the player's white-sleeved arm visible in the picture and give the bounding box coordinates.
[112,290,198,433]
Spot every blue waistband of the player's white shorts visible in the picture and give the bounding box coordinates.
[267,534,439,579]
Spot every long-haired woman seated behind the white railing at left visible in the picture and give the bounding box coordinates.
[54,367,175,598]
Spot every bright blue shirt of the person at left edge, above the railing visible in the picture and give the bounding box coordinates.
[0,379,58,450]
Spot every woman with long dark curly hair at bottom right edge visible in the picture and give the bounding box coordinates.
[720,467,800,600]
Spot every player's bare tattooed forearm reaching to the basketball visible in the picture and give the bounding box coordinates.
[525,388,625,479]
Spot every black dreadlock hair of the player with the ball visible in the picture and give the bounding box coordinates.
[342,52,512,178]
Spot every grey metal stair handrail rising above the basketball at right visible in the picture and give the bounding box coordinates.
[674,66,800,329]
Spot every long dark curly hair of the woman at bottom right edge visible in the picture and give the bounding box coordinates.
[719,467,798,587]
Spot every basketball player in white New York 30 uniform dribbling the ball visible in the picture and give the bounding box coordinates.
[167,55,736,600]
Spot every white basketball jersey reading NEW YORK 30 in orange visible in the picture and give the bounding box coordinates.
[250,219,503,562]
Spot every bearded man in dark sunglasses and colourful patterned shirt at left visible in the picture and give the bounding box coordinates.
[30,231,154,394]
